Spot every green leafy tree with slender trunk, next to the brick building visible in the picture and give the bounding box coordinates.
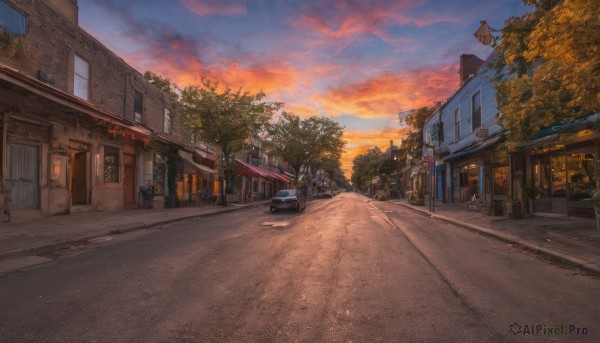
[181,79,282,205]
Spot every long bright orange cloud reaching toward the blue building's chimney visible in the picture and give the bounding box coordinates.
[311,65,458,118]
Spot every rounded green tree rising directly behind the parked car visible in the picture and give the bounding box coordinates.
[267,112,346,197]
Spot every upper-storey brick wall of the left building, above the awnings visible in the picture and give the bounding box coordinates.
[0,0,180,135]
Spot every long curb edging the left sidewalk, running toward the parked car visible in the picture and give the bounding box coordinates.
[0,204,268,260]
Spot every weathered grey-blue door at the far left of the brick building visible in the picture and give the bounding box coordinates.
[7,144,39,210]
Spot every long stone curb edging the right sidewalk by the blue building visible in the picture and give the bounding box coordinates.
[390,201,600,275]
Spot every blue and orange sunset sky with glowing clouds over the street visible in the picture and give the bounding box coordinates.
[78,0,532,177]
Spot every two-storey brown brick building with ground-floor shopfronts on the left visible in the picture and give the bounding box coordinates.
[0,0,216,219]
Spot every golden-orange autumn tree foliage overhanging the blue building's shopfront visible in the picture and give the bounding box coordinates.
[495,0,600,151]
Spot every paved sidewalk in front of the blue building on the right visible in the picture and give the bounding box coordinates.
[390,199,600,274]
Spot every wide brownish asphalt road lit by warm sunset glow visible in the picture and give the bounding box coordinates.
[0,193,600,342]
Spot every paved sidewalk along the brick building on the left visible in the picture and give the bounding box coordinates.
[0,200,270,260]
